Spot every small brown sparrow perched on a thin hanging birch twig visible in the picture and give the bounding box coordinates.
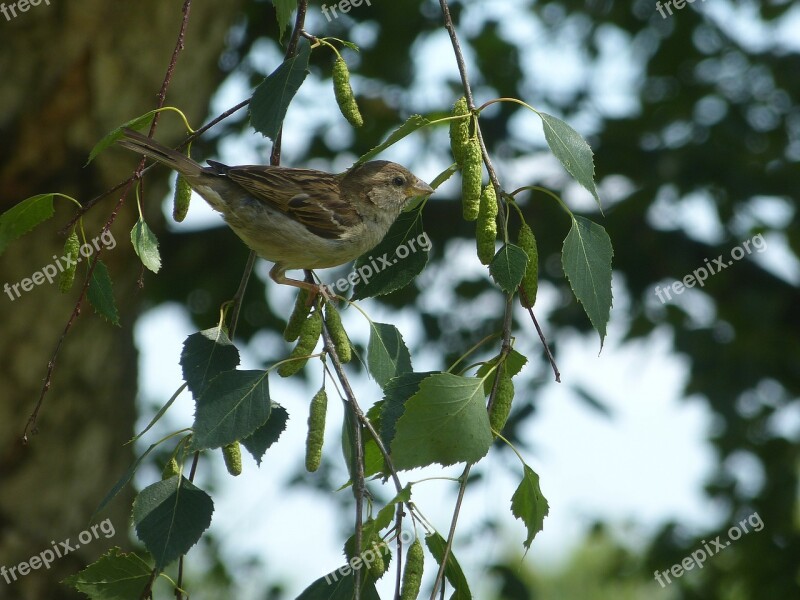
[118,129,433,297]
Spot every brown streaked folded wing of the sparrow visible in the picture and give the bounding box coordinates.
[225,166,362,239]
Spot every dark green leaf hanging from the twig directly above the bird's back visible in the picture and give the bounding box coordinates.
[250,38,311,140]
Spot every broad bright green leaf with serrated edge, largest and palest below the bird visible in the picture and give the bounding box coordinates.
[391,373,493,469]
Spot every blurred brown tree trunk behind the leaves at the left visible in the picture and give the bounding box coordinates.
[0,0,241,600]
